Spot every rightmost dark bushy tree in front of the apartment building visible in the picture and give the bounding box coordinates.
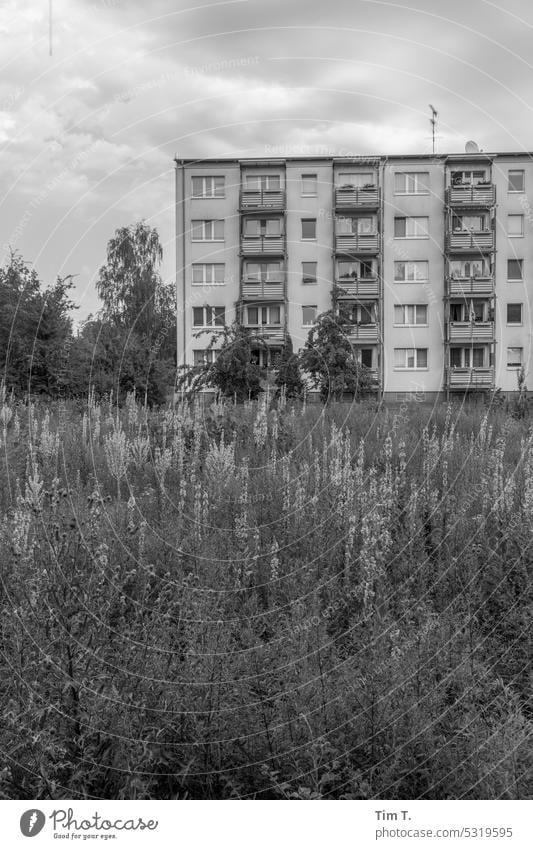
[300,299,371,403]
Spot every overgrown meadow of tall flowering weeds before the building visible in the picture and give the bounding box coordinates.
[0,393,533,799]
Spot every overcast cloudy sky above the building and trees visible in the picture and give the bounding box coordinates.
[0,0,533,318]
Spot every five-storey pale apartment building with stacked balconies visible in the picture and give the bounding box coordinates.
[176,152,533,399]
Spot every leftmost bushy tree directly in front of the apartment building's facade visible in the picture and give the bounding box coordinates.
[178,322,266,403]
